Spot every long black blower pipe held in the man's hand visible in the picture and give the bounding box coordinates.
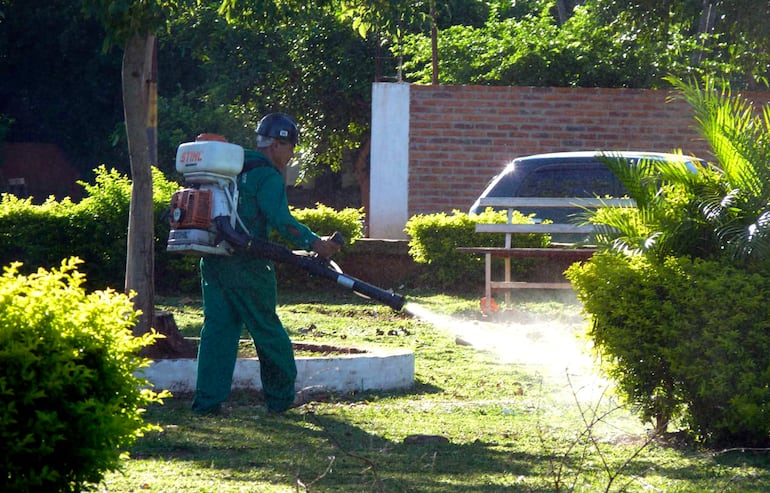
[214,216,405,310]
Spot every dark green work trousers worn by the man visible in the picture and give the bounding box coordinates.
[192,259,297,413]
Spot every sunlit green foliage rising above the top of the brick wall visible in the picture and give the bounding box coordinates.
[393,0,767,88]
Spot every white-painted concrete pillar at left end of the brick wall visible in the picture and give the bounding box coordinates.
[369,82,409,239]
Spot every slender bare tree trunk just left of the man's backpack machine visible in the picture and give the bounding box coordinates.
[123,34,155,335]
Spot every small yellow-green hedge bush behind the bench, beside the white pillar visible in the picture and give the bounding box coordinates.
[404,209,550,289]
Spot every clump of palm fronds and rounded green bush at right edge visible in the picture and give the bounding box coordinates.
[568,79,770,444]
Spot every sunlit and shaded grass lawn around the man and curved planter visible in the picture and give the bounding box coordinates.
[99,288,770,493]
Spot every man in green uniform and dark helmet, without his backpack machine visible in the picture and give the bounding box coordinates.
[192,113,340,414]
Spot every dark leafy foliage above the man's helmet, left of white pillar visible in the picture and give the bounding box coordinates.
[159,2,375,181]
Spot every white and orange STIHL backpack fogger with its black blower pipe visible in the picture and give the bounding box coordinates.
[166,135,405,310]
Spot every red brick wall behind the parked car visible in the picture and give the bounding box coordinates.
[408,85,770,216]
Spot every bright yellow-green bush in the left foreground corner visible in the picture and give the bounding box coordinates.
[0,259,164,492]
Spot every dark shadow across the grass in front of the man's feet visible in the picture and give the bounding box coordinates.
[131,392,560,493]
